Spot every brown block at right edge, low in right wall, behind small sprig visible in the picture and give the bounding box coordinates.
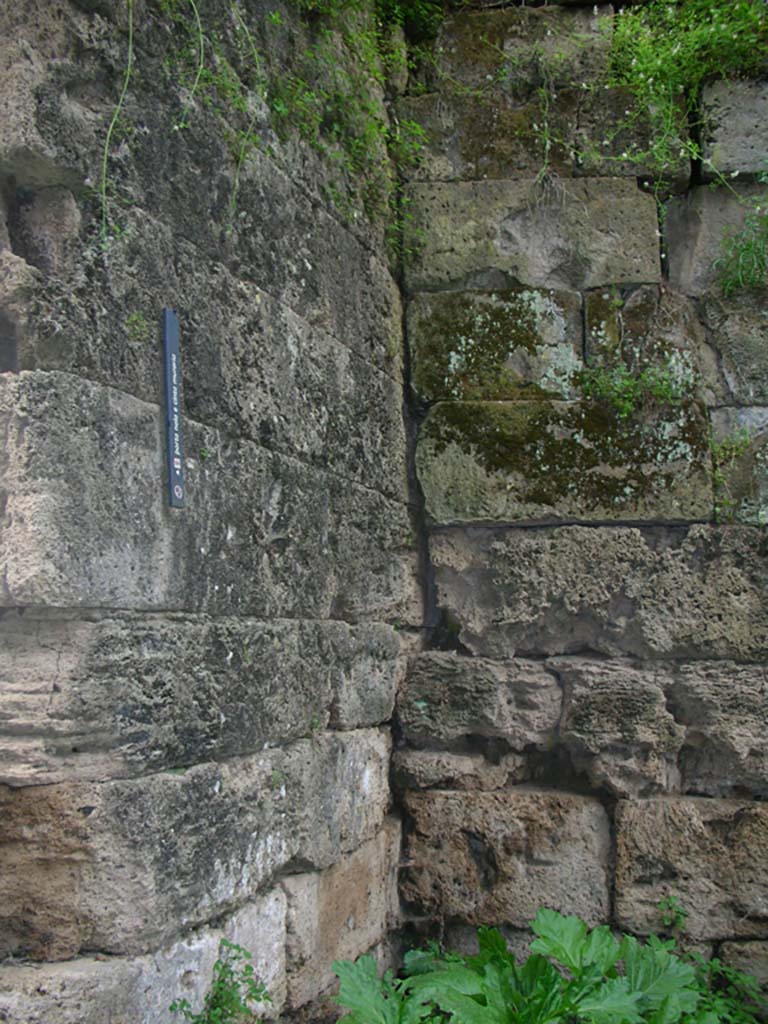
[615,799,768,939]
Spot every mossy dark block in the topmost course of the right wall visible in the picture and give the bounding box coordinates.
[436,4,611,96]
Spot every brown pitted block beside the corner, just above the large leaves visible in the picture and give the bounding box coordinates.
[402,788,610,928]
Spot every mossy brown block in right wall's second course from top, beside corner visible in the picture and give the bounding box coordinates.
[397,91,578,181]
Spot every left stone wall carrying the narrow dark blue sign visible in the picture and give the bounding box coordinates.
[0,0,421,1024]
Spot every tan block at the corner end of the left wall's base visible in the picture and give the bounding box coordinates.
[283,818,400,1008]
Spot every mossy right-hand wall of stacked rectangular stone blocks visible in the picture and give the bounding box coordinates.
[394,3,768,973]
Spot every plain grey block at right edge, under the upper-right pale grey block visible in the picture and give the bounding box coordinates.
[665,184,759,297]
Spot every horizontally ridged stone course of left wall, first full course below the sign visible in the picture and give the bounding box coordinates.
[0,611,400,785]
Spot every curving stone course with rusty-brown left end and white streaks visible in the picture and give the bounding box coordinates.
[0,730,390,959]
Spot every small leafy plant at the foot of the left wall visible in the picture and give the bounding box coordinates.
[169,939,270,1024]
